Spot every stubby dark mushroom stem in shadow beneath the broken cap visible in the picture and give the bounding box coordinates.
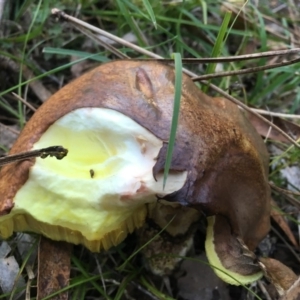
[137,200,201,276]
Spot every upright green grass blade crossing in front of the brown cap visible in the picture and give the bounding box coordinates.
[163,53,182,188]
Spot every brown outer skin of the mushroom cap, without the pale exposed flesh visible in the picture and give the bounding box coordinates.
[0,61,270,282]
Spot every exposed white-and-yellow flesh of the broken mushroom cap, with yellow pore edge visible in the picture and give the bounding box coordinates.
[0,108,186,251]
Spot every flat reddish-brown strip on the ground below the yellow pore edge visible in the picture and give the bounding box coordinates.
[37,237,72,300]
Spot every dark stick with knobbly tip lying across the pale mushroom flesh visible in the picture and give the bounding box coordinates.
[0,146,68,166]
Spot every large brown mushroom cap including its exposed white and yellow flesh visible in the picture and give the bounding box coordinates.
[0,61,270,283]
